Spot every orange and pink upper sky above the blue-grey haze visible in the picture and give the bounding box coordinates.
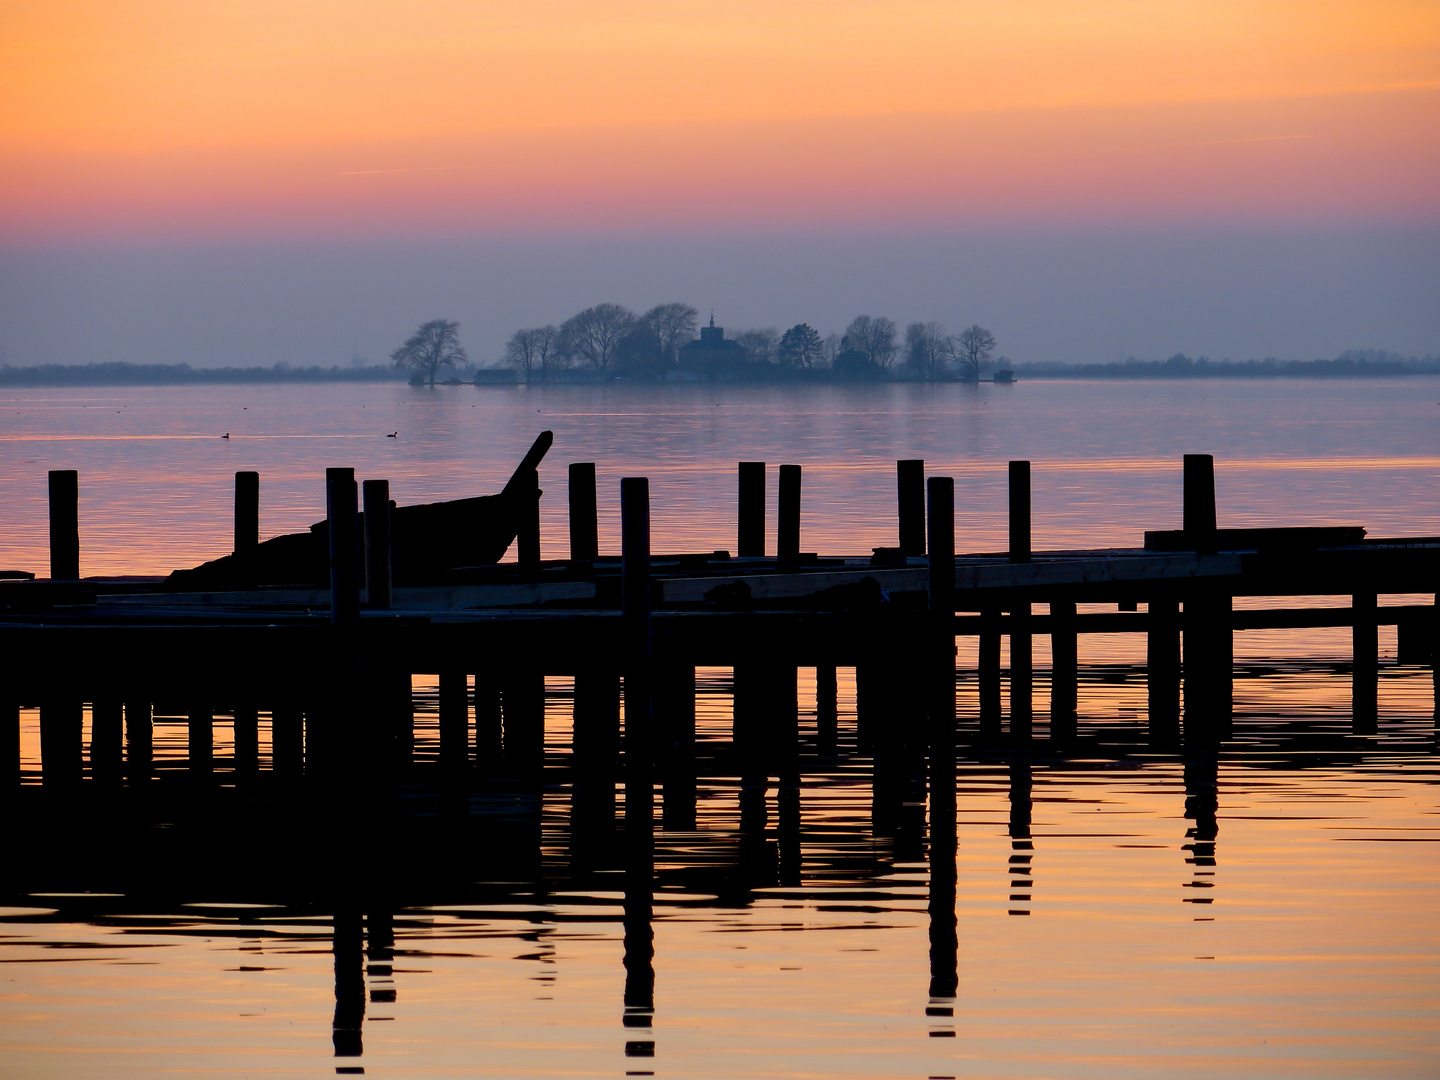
[0,0,1440,236]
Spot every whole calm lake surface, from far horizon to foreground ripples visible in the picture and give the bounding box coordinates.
[0,379,1440,1080]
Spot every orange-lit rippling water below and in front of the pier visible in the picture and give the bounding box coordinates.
[0,665,1440,1077]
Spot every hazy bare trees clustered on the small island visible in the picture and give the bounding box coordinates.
[390,302,995,384]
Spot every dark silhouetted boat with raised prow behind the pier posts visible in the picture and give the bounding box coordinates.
[166,431,554,592]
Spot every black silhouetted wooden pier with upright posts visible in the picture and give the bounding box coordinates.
[0,455,1440,806]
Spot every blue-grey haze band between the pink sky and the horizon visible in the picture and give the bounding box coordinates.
[0,225,1440,366]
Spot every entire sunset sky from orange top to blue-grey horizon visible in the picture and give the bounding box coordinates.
[0,0,1440,363]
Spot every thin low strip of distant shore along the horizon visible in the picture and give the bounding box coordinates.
[0,356,1440,389]
